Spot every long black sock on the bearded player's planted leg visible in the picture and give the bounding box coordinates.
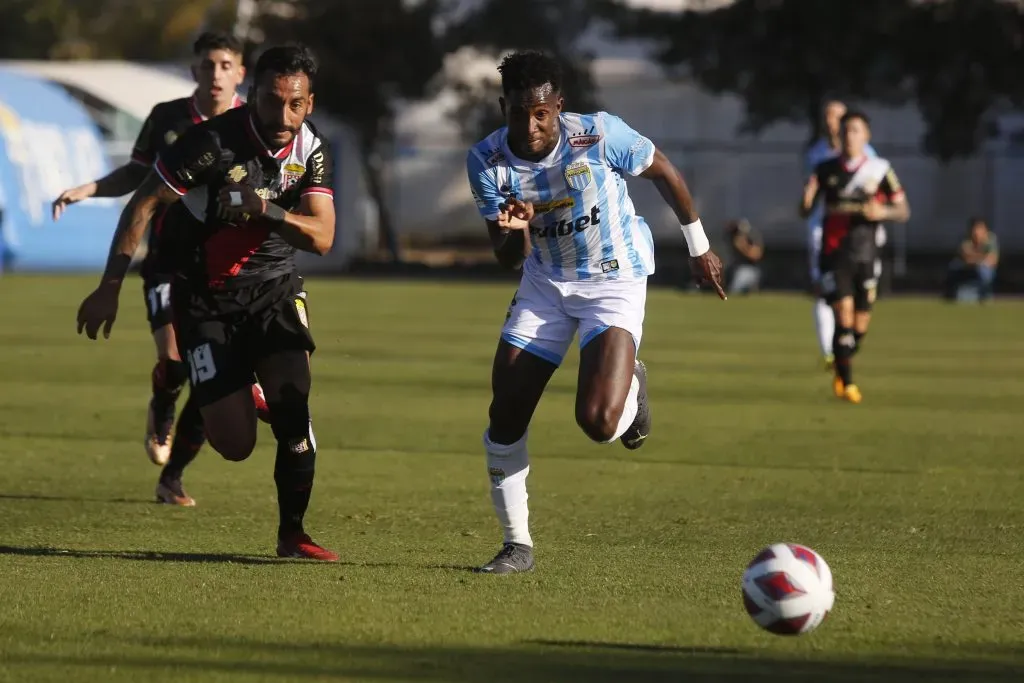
[268,396,316,538]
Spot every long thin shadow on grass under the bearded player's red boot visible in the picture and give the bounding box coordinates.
[0,546,475,572]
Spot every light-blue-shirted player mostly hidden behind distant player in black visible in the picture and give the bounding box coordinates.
[804,99,885,372]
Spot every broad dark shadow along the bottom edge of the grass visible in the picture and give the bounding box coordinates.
[7,638,1024,683]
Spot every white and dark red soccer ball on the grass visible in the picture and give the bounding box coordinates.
[743,543,836,636]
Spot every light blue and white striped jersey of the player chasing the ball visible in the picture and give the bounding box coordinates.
[466,112,654,281]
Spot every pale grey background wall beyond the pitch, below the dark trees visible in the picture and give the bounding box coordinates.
[390,59,1024,250]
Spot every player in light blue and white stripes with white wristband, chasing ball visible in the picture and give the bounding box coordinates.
[466,52,725,573]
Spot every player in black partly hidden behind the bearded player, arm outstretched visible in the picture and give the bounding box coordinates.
[53,33,259,507]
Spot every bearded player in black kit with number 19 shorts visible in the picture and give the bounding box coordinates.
[78,46,338,561]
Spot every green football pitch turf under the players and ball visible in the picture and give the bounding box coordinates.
[0,276,1024,683]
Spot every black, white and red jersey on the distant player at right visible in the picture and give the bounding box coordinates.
[814,156,903,262]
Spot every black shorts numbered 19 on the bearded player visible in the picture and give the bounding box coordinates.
[172,274,316,405]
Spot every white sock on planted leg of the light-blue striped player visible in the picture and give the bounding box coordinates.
[483,432,534,547]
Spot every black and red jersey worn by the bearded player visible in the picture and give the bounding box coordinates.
[155,105,334,289]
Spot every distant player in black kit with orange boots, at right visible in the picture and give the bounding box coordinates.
[800,111,910,403]
